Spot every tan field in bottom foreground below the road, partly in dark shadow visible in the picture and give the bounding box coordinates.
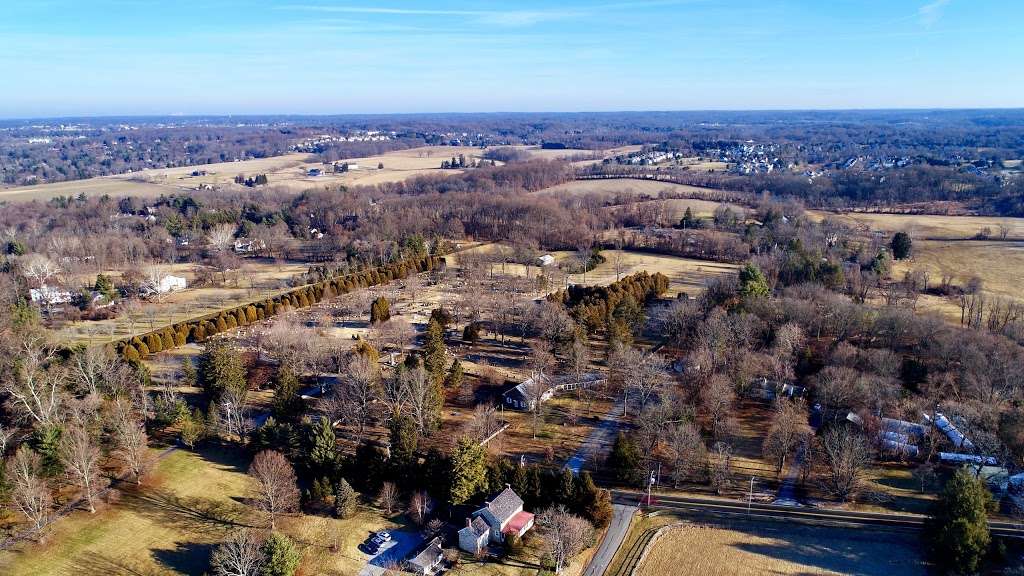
[635,524,927,576]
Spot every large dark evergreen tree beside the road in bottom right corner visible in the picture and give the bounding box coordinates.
[925,467,992,574]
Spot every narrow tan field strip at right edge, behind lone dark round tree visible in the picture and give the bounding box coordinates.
[807,210,1024,241]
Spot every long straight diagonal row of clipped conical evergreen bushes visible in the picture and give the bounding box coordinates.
[116,256,441,360]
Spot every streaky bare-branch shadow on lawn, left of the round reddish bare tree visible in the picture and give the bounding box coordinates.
[122,489,252,536]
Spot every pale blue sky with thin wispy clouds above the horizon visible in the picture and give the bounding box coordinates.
[0,0,1024,118]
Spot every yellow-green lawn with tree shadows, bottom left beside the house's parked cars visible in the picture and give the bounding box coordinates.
[0,449,397,576]
